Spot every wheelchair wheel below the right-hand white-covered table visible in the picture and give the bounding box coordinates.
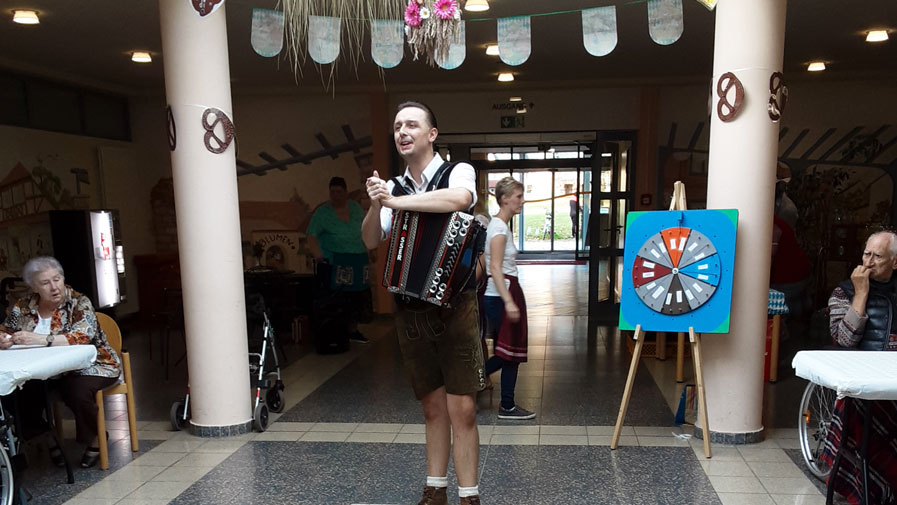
[797,382,837,482]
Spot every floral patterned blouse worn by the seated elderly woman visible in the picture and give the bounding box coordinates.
[2,285,121,378]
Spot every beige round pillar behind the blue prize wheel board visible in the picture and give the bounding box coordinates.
[702,0,786,443]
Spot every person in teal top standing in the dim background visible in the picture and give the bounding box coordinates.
[306,177,371,344]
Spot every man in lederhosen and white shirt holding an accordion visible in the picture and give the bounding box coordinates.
[362,102,486,505]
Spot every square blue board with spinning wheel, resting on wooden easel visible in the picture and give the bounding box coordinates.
[619,209,738,333]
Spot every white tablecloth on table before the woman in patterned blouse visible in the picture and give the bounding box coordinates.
[0,345,97,396]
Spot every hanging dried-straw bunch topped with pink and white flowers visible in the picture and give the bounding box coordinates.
[404,0,461,66]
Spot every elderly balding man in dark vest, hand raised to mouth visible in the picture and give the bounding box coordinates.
[821,231,897,504]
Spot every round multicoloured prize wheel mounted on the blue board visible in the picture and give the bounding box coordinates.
[632,227,721,316]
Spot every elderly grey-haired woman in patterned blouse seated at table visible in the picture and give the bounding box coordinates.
[0,257,121,468]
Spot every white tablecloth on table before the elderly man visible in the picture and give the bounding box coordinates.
[791,351,897,400]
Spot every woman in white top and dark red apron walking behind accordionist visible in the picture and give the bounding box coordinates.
[483,177,536,420]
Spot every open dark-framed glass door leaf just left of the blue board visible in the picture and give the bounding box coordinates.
[584,132,635,324]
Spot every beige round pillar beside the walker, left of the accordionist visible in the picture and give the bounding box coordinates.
[159,0,252,436]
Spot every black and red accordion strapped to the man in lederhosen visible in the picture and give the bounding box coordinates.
[383,210,486,307]
